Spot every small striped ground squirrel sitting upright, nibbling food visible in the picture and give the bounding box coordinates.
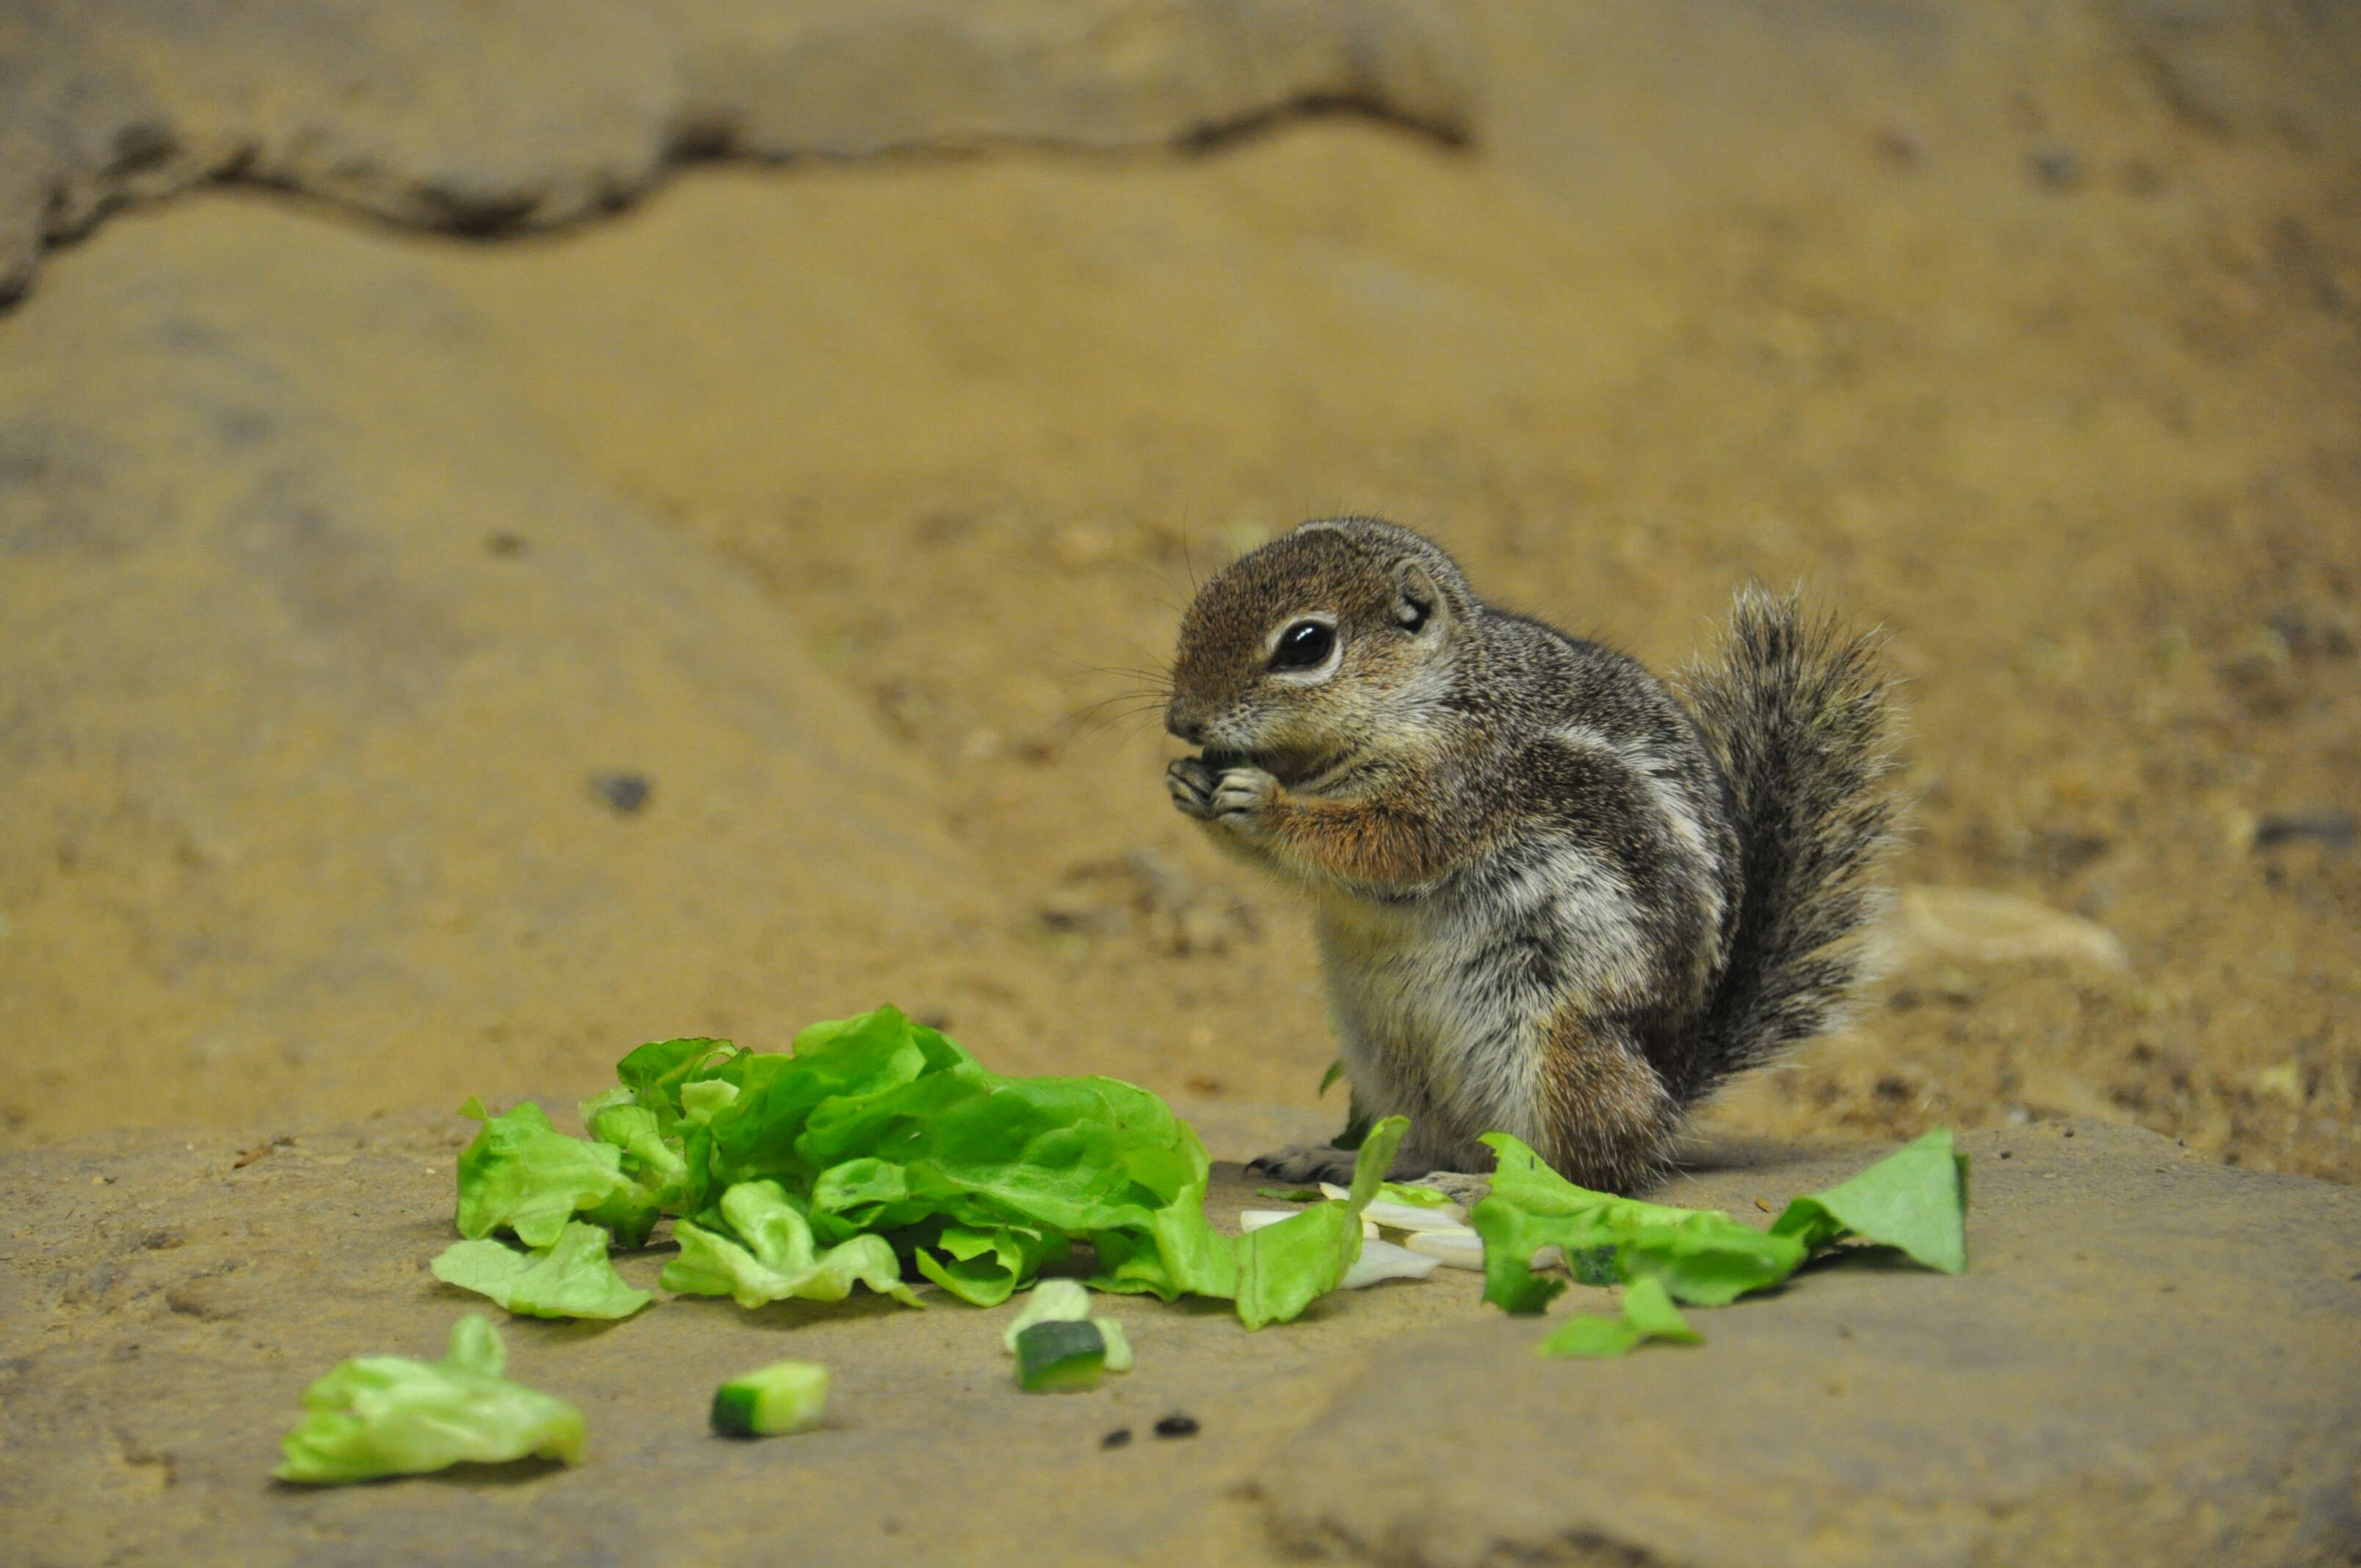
[1167,517,1896,1190]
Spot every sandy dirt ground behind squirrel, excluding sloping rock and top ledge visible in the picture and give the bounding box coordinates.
[0,0,2361,1180]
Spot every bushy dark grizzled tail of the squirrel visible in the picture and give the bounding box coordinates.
[1679,588,1901,1100]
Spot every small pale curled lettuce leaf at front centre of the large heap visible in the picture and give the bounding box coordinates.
[659,1180,918,1308]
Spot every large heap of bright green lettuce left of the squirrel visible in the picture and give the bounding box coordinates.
[458,1006,1384,1325]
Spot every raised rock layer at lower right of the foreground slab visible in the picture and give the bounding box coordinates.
[1266,1122,2361,1568]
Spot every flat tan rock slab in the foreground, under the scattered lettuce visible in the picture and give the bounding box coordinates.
[0,1112,2361,1568]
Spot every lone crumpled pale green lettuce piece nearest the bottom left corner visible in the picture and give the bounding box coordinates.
[272,1313,583,1483]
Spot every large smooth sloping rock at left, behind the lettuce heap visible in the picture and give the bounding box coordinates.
[0,184,987,1124]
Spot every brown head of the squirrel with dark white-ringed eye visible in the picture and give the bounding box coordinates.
[1164,517,1476,784]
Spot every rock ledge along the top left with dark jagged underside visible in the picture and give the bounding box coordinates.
[0,0,1471,295]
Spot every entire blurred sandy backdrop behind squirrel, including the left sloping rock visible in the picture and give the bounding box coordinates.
[0,0,2361,1180]
